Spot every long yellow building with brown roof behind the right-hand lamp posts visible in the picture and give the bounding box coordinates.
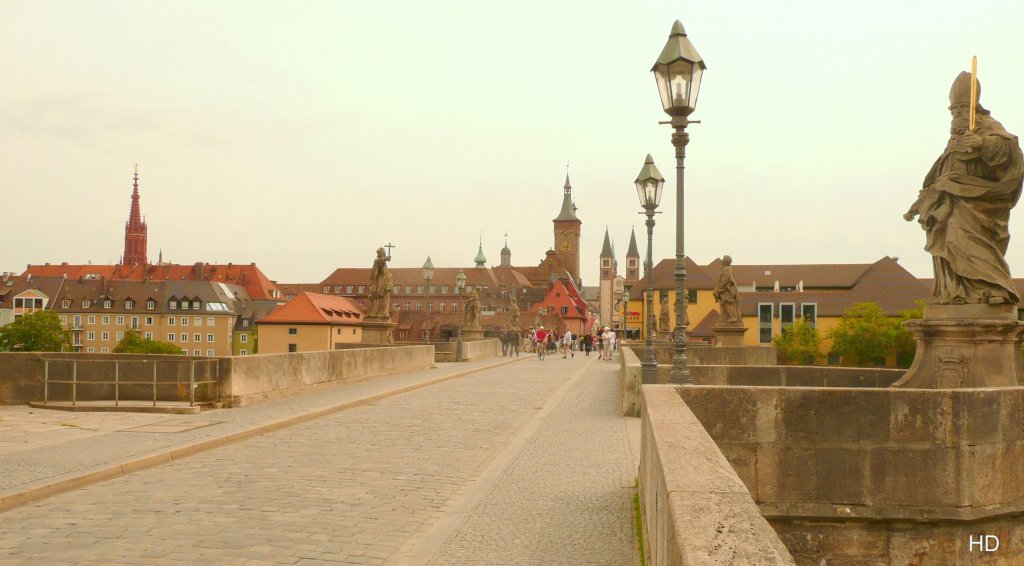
[629,257,929,362]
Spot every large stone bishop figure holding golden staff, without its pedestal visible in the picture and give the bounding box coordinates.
[903,72,1024,305]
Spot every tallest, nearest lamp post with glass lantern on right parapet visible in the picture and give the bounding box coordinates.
[651,19,708,383]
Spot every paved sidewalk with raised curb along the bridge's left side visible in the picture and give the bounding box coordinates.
[0,356,529,513]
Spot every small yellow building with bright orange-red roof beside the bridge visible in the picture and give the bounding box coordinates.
[257,292,364,354]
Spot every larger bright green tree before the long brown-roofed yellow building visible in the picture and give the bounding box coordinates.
[828,303,903,367]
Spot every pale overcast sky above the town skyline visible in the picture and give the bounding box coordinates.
[0,0,1024,285]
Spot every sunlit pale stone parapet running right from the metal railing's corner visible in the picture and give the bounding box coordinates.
[220,346,434,406]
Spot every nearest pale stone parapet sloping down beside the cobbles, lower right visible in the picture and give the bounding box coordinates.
[640,385,794,566]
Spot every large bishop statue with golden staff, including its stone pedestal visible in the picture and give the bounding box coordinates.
[893,73,1024,389]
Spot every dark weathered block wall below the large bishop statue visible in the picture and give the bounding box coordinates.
[677,386,1024,566]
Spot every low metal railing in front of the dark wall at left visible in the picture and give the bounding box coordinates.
[43,359,220,406]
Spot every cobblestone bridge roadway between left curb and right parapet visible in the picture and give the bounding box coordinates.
[0,352,636,565]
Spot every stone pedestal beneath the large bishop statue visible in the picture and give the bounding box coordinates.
[892,304,1024,389]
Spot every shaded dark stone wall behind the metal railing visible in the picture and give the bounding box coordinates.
[0,352,209,404]
